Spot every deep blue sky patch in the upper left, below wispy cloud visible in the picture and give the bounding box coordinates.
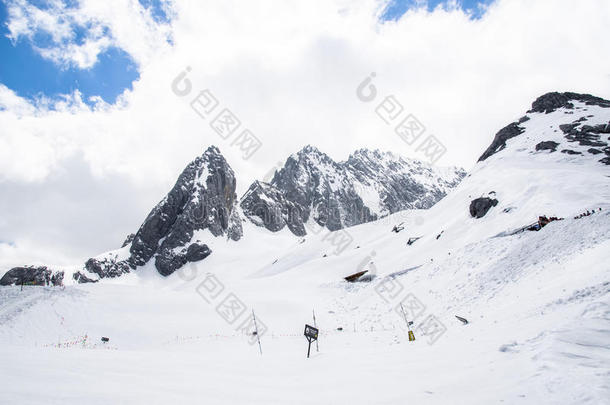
[0,0,169,104]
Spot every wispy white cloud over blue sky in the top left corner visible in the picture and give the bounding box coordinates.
[7,0,171,69]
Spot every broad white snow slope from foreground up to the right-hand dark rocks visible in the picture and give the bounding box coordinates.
[0,96,610,404]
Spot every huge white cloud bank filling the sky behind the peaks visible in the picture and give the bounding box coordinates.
[0,0,610,270]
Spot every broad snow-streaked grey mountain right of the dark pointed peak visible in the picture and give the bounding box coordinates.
[240,145,466,236]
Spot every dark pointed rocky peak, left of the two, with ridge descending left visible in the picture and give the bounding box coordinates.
[86,146,242,280]
